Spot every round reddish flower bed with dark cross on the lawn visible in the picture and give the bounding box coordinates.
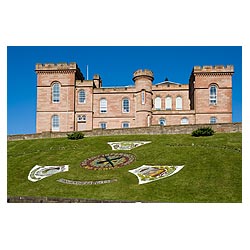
[80,153,135,170]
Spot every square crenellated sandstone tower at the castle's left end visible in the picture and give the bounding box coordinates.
[35,63,84,133]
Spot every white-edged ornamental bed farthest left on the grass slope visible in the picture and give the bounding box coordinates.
[28,165,69,182]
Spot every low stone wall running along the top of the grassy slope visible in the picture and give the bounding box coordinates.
[7,122,242,141]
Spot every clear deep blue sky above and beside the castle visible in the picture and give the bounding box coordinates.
[7,46,242,134]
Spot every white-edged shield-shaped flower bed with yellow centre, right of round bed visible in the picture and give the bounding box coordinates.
[129,165,184,184]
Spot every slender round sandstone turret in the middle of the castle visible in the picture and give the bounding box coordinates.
[133,69,154,127]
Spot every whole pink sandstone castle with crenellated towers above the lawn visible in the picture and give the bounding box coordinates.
[35,63,234,133]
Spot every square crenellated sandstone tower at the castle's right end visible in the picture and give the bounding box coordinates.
[189,65,234,124]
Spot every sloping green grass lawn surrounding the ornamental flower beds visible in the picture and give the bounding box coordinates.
[7,133,242,202]
